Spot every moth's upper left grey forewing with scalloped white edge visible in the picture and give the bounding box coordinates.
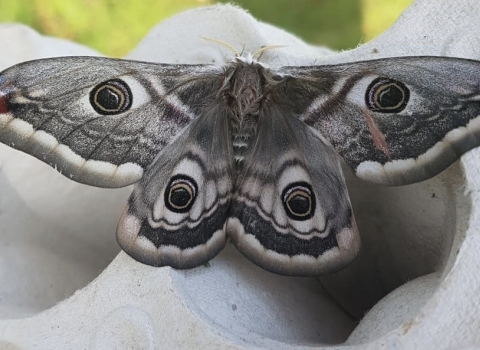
[0,57,221,187]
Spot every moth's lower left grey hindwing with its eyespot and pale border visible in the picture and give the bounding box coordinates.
[117,104,232,269]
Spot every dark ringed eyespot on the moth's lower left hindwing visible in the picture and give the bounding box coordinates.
[164,175,198,213]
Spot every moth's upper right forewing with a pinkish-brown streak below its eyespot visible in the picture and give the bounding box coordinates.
[281,57,480,185]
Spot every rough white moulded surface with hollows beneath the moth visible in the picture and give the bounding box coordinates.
[0,0,480,349]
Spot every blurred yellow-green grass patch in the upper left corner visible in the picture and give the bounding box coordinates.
[0,0,203,57]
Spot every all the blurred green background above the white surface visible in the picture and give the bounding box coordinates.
[0,0,412,57]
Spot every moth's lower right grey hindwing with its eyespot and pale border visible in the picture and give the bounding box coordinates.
[227,107,360,276]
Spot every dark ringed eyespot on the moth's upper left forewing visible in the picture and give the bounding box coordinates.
[90,79,132,115]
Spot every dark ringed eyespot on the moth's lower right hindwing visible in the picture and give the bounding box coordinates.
[282,181,315,221]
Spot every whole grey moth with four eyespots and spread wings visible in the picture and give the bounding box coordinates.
[0,51,480,276]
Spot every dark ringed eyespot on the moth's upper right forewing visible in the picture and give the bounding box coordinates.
[365,78,410,113]
